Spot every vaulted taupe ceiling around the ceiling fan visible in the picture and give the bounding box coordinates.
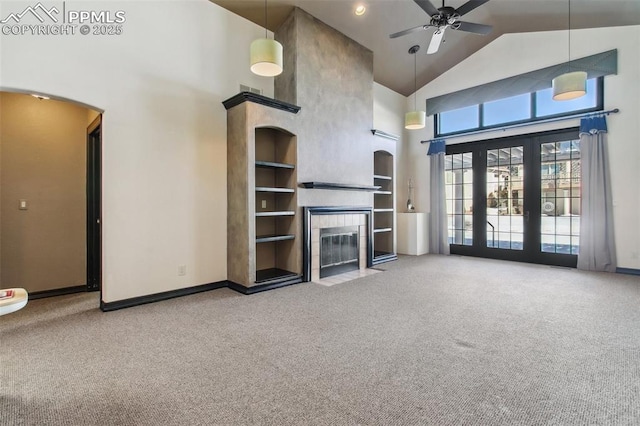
[210,0,640,96]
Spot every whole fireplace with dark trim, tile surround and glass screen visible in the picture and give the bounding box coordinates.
[303,207,372,281]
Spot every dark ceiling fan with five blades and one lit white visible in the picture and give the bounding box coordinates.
[389,0,493,54]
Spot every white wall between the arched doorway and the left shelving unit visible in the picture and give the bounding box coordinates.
[0,0,273,302]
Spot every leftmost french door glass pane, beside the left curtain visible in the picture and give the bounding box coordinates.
[445,152,473,246]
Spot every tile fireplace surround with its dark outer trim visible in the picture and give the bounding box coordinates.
[303,207,373,281]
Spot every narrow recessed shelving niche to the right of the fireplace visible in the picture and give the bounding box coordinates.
[373,151,397,264]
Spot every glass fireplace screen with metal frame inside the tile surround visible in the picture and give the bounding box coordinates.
[320,226,360,278]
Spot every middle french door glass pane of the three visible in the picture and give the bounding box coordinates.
[487,146,524,250]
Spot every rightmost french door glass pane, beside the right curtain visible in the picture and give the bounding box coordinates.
[540,140,580,254]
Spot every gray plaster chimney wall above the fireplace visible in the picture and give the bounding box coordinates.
[274,8,374,206]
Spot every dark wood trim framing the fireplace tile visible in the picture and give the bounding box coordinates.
[302,206,373,282]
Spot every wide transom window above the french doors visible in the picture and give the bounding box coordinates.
[434,77,604,137]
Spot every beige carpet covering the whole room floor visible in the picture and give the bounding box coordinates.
[0,256,640,425]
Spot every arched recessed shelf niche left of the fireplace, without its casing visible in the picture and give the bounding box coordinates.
[254,128,301,284]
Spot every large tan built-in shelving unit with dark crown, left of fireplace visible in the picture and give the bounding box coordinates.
[222,92,304,294]
